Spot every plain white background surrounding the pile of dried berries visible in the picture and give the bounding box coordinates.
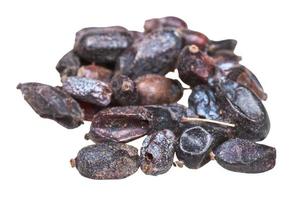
[0,0,295,200]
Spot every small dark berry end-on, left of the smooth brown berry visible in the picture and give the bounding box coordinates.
[111,74,139,106]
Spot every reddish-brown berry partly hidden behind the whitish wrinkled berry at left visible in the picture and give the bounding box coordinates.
[77,64,113,82]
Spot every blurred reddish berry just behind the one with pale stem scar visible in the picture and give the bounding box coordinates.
[179,29,209,50]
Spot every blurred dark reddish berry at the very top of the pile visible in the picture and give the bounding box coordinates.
[144,16,187,33]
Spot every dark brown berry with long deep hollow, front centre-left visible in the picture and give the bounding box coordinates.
[87,106,153,142]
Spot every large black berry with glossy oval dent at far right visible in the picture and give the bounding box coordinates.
[218,80,270,141]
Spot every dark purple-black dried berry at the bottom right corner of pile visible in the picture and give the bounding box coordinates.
[214,138,276,173]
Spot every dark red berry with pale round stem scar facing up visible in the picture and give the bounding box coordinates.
[176,45,214,87]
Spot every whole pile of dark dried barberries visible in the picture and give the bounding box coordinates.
[17,17,276,179]
